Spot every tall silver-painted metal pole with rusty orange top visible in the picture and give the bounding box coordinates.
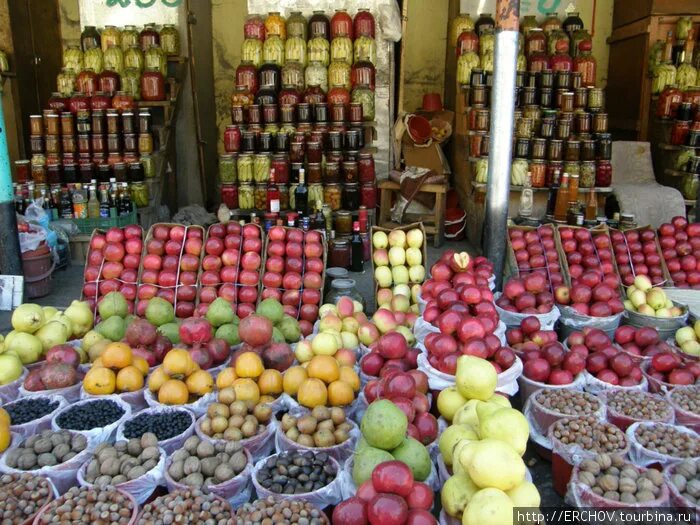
[484,0,520,289]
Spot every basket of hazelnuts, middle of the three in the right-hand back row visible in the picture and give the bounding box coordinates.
[598,389,673,431]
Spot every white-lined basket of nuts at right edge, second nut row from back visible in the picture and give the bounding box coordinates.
[625,423,700,467]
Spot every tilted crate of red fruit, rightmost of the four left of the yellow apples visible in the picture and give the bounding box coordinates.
[260,226,327,326]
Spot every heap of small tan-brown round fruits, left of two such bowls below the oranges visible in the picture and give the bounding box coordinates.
[197,387,273,441]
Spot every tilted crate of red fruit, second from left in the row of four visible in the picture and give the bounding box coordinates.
[136,223,204,319]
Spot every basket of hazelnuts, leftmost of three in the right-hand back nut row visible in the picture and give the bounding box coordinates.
[523,389,605,434]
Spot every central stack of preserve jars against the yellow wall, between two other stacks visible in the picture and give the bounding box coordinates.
[220,10,376,233]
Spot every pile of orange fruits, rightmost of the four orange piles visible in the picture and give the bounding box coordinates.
[282,354,360,409]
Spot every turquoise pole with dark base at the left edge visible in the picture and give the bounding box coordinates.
[0,79,23,275]
